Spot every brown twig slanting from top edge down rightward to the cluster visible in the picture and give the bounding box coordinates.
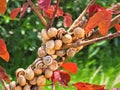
[27,0,47,27]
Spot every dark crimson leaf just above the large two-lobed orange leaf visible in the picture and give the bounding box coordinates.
[89,4,105,18]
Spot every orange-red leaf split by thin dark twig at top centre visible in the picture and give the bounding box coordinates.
[43,5,64,18]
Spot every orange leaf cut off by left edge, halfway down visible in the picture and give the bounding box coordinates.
[0,39,10,62]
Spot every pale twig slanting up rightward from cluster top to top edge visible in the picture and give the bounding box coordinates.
[68,0,96,32]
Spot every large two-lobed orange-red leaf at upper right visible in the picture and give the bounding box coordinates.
[85,10,112,35]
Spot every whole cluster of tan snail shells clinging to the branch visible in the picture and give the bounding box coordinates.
[2,27,85,90]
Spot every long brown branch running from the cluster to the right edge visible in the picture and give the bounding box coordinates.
[62,32,120,49]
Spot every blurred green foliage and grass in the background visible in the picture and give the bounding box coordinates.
[0,0,120,90]
